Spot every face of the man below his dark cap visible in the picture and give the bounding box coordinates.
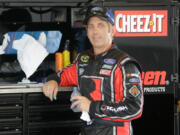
[87,17,114,49]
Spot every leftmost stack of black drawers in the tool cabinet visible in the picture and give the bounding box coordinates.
[0,94,23,135]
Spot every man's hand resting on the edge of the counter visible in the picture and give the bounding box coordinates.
[43,80,58,101]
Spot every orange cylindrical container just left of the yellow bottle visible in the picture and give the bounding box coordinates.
[55,52,63,72]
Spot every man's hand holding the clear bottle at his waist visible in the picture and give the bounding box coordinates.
[71,96,91,112]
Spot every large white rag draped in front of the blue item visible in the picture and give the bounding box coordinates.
[13,34,48,78]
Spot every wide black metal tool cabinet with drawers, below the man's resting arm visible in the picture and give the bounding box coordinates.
[0,88,84,135]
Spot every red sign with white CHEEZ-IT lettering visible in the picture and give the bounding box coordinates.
[114,10,168,37]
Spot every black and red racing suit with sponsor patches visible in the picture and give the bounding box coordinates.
[48,45,143,135]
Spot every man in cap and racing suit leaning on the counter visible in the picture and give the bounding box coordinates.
[43,7,143,135]
